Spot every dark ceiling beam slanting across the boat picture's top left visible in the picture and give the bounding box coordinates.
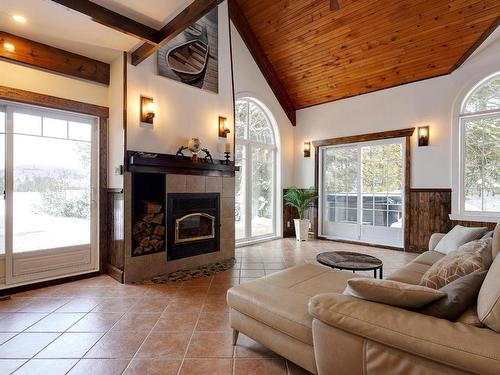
[132,0,223,65]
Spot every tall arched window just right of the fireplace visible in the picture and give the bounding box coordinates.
[235,98,277,242]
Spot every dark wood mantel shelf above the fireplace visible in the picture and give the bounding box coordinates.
[127,151,240,176]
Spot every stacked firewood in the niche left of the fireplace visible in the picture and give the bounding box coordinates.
[133,200,165,255]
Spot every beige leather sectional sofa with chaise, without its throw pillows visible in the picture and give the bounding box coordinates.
[227,227,500,375]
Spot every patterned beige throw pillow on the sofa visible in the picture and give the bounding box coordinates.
[420,240,492,289]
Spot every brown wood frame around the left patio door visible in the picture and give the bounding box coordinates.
[0,86,109,278]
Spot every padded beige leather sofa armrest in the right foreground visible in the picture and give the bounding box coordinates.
[309,293,500,374]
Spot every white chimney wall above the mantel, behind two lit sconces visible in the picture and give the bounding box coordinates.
[127,3,234,158]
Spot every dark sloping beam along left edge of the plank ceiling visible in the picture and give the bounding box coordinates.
[228,0,296,126]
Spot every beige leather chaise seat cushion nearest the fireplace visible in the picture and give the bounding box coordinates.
[227,264,359,345]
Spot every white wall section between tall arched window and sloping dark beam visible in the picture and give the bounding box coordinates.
[231,24,294,188]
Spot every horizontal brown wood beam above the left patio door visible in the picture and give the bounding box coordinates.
[0,31,109,85]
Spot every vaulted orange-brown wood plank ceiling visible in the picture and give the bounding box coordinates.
[236,0,500,109]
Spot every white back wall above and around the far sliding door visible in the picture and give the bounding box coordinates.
[293,35,500,188]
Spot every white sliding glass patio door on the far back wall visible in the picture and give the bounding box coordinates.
[319,138,405,247]
